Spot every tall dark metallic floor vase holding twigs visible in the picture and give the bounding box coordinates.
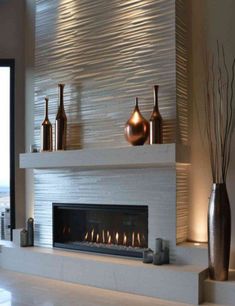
[208,183,231,281]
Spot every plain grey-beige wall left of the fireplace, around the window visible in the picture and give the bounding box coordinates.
[0,0,25,227]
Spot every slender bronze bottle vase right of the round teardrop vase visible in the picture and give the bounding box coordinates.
[149,85,162,144]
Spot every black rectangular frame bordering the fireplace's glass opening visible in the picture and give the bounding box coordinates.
[52,203,148,258]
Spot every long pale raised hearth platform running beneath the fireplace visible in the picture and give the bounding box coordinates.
[0,243,207,304]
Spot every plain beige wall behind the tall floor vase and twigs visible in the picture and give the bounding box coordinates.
[189,0,235,268]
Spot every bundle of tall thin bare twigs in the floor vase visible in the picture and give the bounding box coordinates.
[205,42,235,183]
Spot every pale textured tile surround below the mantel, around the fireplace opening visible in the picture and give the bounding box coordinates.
[35,168,176,256]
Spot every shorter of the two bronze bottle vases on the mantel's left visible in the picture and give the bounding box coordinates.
[41,98,53,152]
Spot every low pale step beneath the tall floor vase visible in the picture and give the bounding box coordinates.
[204,270,235,306]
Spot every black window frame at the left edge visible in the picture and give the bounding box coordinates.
[0,59,15,240]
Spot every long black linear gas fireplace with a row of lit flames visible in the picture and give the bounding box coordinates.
[53,203,148,257]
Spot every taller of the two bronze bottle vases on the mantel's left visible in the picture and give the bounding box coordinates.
[55,84,67,151]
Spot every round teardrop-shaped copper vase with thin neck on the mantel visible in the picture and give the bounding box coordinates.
[125,98,149,146]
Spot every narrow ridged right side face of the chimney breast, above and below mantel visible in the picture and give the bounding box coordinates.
[176,0,190,243]
